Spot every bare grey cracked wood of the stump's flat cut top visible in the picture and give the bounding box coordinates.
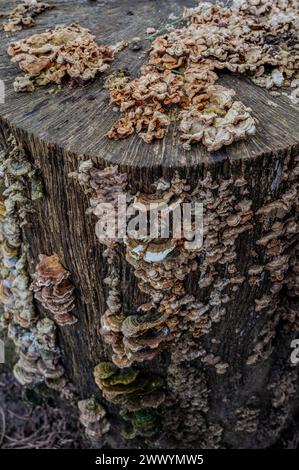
[0,0,299,167]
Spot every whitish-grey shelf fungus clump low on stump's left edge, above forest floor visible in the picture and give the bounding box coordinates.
[8,318,66,390]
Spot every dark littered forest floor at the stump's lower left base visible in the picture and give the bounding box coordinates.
[0,366,89,449]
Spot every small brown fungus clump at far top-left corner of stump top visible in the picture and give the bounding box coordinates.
[0,0,54,32]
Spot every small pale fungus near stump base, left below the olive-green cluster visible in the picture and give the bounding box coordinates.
[78,397,110,442]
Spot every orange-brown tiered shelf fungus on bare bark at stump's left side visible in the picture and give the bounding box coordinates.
[31,255,78,326]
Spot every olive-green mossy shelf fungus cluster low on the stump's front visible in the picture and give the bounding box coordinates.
[94,362,165,439]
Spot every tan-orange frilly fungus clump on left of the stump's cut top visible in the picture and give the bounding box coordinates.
[7,24,124,91]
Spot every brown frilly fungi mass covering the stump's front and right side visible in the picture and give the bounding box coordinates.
[70,145,299,448]
